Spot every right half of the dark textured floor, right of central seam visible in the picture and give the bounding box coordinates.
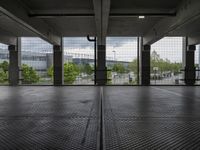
[104,87,200,150]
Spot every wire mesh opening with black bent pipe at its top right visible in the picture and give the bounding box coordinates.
[63,37,94,85]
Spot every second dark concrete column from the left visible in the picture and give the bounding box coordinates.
[53,44,64,85]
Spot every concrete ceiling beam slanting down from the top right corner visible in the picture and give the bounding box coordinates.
[143,0,200,44]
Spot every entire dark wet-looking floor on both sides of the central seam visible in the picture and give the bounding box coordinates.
[0,86,200,150]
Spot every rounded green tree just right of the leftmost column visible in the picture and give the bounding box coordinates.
[22,64,40,83]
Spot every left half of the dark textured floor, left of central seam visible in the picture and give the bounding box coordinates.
[0,87,99,150]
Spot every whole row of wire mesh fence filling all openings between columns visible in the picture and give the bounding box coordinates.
[0,37,200,85]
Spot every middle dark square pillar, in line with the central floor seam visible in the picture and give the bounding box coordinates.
[96,45,107,85]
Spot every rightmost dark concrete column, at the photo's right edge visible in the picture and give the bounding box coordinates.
[184,42,196,85]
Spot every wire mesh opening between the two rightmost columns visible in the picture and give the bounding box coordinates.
[150,37,184,85]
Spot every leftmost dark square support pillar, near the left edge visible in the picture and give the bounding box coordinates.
[8,45,19,86]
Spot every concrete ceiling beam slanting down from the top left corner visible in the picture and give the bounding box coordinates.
[0,0,61,45]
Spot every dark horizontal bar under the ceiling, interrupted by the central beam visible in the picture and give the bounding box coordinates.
[29,9,176,18]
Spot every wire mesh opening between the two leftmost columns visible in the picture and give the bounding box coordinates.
[20,37,53,85]
